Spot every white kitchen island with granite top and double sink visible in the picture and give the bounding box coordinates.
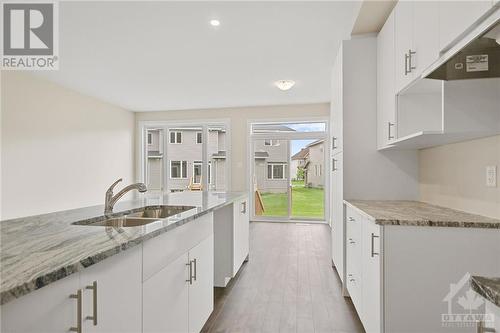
[0,192,248,332]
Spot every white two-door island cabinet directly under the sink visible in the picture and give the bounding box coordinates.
[142,215,214,333]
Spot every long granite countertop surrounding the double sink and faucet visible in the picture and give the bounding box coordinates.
[0,192,247,304]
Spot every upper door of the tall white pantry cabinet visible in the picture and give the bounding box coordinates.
[330,46,344,154]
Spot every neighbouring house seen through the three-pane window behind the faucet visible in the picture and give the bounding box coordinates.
[147,127,226,192]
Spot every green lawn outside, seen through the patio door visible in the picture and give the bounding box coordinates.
[262,181,325,218]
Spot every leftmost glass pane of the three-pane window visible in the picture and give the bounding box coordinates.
[145,128,163,192]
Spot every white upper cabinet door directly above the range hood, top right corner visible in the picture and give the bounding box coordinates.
[439,0,492,50]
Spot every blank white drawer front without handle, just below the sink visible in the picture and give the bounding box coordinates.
[142,213,213,281]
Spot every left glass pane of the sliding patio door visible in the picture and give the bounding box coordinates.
[253,140,289,218]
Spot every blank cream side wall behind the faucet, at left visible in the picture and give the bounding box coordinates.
[1,71,135,219]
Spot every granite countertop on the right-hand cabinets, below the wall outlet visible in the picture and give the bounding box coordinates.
[344,200,500,229]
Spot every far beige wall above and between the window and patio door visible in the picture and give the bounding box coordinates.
[135,103,330,191]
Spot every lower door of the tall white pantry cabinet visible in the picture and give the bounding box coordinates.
[330,153,344,282]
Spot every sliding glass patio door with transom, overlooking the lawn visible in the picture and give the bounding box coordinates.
[251,123,327,221]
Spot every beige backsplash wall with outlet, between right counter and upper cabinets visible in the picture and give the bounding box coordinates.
[419,135,500,219]
